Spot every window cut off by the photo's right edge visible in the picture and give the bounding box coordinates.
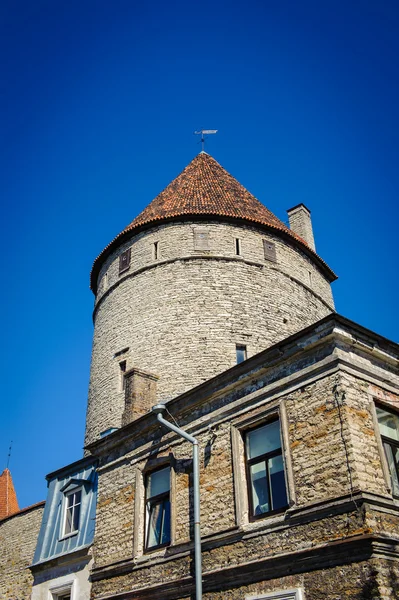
[376,406,399,496]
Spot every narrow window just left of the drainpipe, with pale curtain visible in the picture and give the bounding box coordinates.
[145,467,170,550]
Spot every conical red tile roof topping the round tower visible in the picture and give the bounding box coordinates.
[90,152,336,292]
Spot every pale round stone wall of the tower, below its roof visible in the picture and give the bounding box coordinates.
[85,221,334,444]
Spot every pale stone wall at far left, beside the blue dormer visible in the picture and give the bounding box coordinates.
[0,504,44,600]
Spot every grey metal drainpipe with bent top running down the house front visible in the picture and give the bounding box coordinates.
[152,404,202,600]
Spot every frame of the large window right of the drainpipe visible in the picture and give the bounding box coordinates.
[243,414,290,523]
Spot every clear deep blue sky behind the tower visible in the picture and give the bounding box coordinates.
[0,0,399,506]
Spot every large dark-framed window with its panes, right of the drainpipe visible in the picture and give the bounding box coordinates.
[245,420,288,519]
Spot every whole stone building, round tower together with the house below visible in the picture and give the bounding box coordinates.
[0,152,399,600]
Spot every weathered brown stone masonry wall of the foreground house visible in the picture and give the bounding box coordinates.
[93,372,399,600]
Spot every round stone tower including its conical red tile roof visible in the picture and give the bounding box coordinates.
[85,152,336,444]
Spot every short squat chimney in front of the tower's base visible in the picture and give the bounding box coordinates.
[122,367,159,425]
